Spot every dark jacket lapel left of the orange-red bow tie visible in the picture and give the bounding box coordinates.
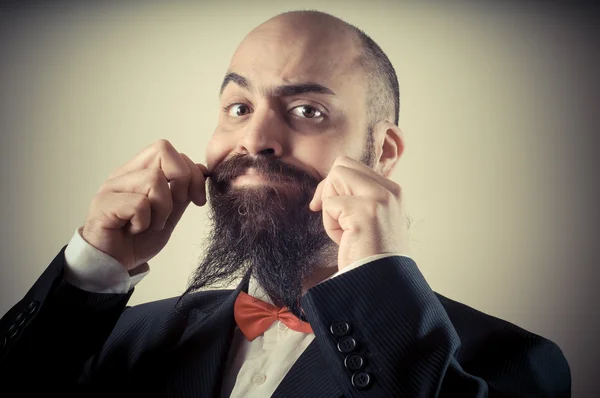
[167,278,248,397]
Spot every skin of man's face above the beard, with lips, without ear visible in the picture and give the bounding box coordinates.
[206,20,376,181]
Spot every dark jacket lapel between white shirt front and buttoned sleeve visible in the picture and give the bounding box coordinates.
[272,340,342,398]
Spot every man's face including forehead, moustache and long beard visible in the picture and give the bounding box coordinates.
[188,15,378,317]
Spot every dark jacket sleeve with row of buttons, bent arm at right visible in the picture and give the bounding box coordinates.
[302,256,571,398]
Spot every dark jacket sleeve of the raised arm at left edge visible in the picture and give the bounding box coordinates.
[0,246,133,396]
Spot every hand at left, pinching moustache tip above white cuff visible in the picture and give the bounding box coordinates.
[82,140,208,271]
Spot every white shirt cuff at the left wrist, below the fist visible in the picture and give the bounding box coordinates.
[64,227,150,294]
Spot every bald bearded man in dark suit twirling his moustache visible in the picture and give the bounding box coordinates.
[0,12,570,397]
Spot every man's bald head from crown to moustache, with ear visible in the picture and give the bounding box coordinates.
[211,11,398,177]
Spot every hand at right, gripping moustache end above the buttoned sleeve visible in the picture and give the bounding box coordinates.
[310,156,409,270]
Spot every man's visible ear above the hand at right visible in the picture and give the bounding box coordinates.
[373,120,404,177]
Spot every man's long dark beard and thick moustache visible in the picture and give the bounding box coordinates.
[180,129,374,319]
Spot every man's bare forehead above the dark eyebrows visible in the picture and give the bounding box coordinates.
[229,26,364,95]
